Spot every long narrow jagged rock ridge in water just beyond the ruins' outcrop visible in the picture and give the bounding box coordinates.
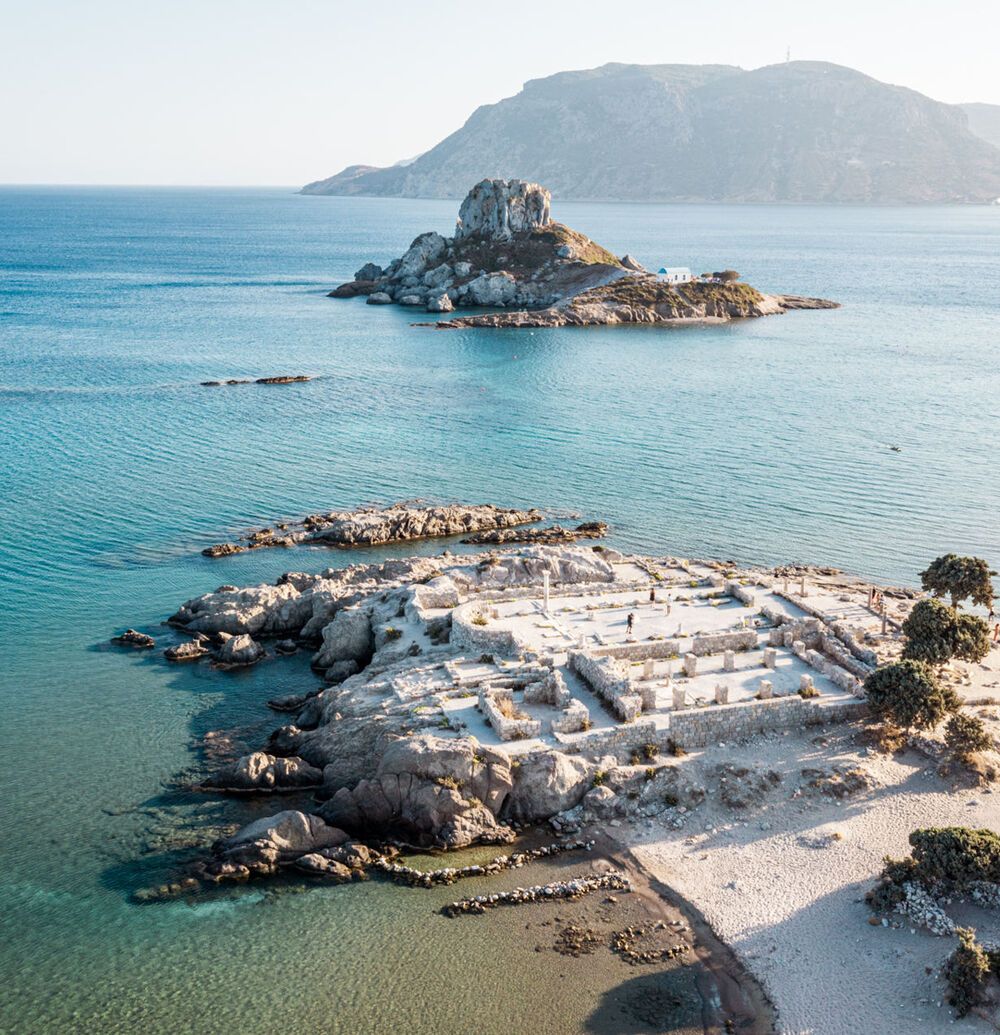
[202,500,542,557]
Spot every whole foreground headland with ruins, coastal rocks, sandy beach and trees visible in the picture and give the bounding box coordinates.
[116,501,1000,1035]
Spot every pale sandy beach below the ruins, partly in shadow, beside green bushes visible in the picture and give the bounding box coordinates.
[630,707,1000,1035]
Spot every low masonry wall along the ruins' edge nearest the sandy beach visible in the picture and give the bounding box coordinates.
[668,694,867,749]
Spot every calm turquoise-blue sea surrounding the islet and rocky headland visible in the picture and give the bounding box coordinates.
[0,188,1000,1032]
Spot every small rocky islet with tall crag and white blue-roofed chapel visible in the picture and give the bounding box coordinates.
[330,179,839,329]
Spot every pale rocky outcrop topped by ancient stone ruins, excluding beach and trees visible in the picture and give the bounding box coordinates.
[146,544,898,880]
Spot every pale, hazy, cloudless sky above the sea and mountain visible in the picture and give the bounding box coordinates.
[0,0,1000,185]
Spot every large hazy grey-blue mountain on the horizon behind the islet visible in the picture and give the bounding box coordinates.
[303,61,1000,202]
